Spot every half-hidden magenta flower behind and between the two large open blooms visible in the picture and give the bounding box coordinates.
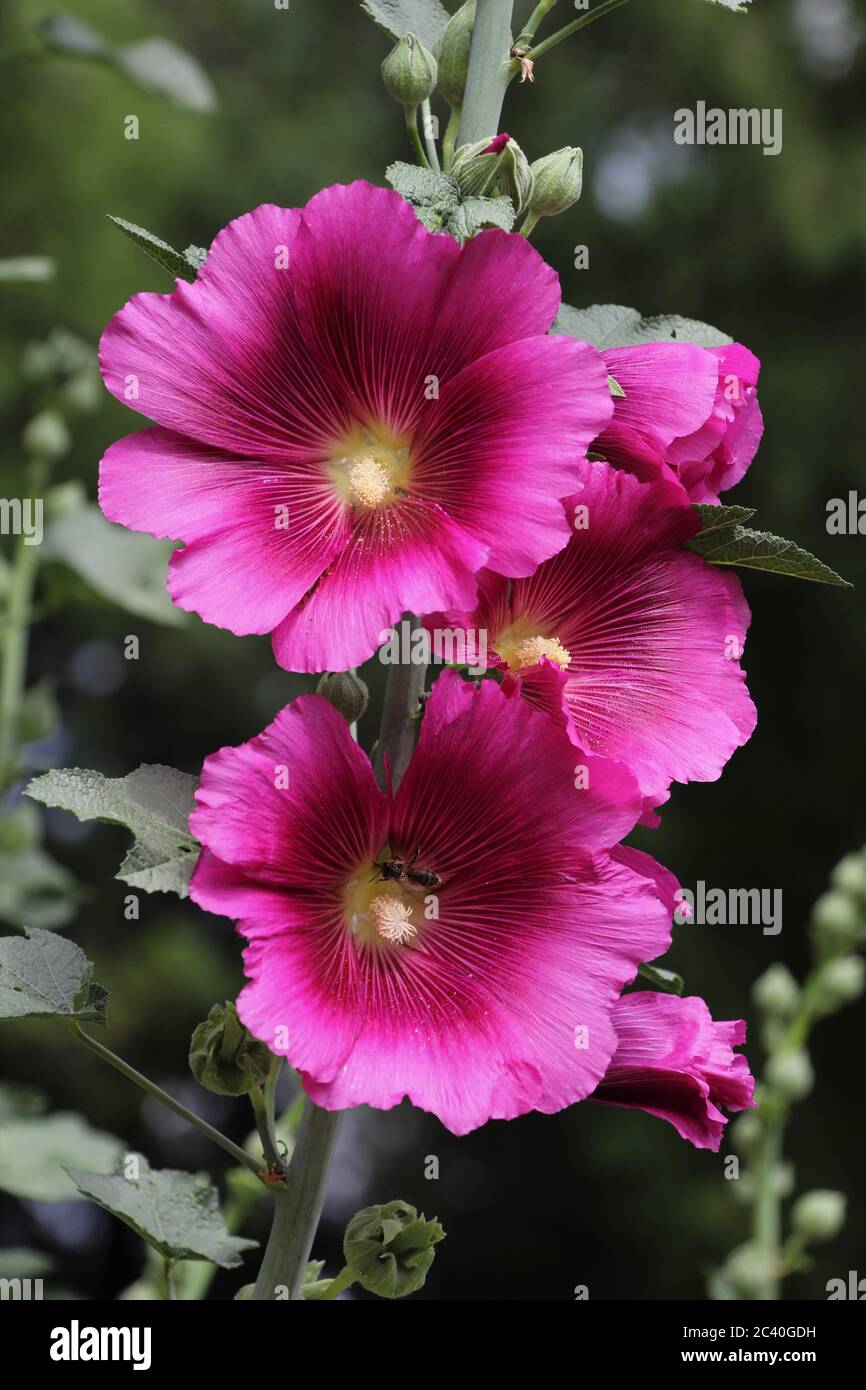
[425,461,756,808]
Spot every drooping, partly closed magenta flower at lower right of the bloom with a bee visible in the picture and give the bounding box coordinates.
[592,991,755,1151]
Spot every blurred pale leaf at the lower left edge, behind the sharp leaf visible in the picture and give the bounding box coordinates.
[0,1113,125,1202]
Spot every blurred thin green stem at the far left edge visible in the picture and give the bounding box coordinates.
[0,459,46,791]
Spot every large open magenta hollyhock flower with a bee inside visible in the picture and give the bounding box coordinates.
[190,671,676,1134]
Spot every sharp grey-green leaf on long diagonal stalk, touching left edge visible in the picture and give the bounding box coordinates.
[0,927,108,1027]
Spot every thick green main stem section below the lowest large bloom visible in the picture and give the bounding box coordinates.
[253,1098,342,1301]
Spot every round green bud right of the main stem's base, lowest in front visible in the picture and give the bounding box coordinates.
[343,1202,445,1298]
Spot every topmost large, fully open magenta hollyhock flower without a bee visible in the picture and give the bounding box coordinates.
[100,182,613,671]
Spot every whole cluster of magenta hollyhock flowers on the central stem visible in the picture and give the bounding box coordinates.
[100,182,762,1148]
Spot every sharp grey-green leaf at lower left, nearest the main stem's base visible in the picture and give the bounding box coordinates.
[70,1154,259,1269]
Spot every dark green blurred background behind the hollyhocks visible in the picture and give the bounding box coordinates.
[0,0,866,1300]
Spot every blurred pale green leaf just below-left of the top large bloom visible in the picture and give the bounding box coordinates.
[42,505,188,627]
